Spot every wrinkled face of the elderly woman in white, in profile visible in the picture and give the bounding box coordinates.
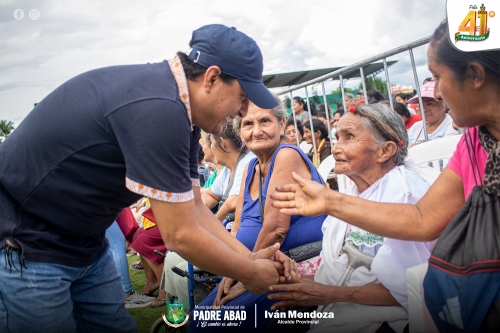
[332,112,377,176]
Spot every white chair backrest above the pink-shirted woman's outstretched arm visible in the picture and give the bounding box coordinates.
[408,134,462,171]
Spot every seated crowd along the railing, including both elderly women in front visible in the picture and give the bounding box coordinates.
[103,68,458,332]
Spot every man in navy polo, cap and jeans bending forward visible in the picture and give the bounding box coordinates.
[0,25,290,332]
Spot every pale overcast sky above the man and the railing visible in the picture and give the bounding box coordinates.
[0,0,446,126]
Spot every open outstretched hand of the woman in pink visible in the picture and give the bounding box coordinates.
[271,172,333,216]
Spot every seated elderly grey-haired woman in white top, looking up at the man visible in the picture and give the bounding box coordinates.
[269,104,438,332]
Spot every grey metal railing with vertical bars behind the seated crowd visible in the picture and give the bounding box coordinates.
[278,36,431,167]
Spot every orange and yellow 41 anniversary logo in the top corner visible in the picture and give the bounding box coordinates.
[455,4,495,44]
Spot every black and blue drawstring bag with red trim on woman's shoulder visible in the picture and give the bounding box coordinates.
[424,127,500,332]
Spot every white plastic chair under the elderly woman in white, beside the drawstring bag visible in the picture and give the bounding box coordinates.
[406,135,462,333]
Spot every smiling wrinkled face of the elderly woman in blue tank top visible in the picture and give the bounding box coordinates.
[240,104,285,155]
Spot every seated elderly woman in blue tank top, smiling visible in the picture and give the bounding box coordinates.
[189,95,326,332]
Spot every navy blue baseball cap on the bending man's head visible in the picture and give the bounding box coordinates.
[188,24,278,109]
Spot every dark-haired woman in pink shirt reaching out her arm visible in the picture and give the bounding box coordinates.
[272,21,500,330]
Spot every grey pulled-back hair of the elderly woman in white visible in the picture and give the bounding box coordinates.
[354,103,408,165]
